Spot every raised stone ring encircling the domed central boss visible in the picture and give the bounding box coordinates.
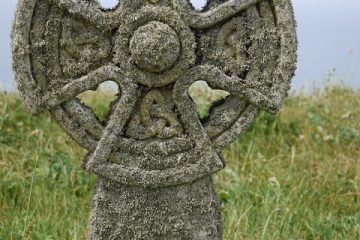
[113,6,196,87]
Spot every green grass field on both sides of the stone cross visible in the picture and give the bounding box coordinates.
[0,86,360,240]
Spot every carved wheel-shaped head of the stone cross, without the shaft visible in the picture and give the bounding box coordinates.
[13,0,296,196]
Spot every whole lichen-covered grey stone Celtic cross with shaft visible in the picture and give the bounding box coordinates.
[12,0,297,240]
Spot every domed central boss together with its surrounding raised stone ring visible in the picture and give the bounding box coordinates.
[114,7,196,87]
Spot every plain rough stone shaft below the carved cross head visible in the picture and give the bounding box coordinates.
[88,177,222,240]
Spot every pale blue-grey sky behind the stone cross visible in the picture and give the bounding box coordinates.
[0,0,360,90]
